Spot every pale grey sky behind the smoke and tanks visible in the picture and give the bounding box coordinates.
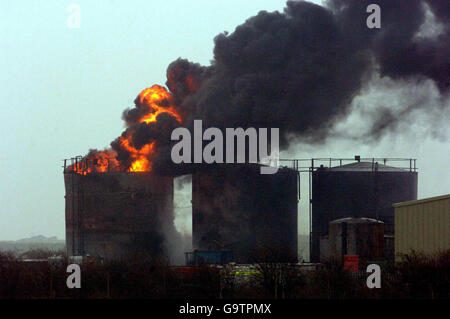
[0,0,450,240]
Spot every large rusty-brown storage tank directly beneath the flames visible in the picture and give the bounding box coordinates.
[64,172,174,259]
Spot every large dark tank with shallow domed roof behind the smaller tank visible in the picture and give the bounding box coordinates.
[311,162,417,262]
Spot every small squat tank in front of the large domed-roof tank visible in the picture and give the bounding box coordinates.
[328,217,384,261]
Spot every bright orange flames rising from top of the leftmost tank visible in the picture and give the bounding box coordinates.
[69,84,181,175]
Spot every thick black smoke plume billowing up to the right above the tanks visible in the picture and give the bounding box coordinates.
[166,0,450,147]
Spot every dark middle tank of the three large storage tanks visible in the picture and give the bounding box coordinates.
[192,164,299,263]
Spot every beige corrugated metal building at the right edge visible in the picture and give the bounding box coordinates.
[393,194,450,256]
